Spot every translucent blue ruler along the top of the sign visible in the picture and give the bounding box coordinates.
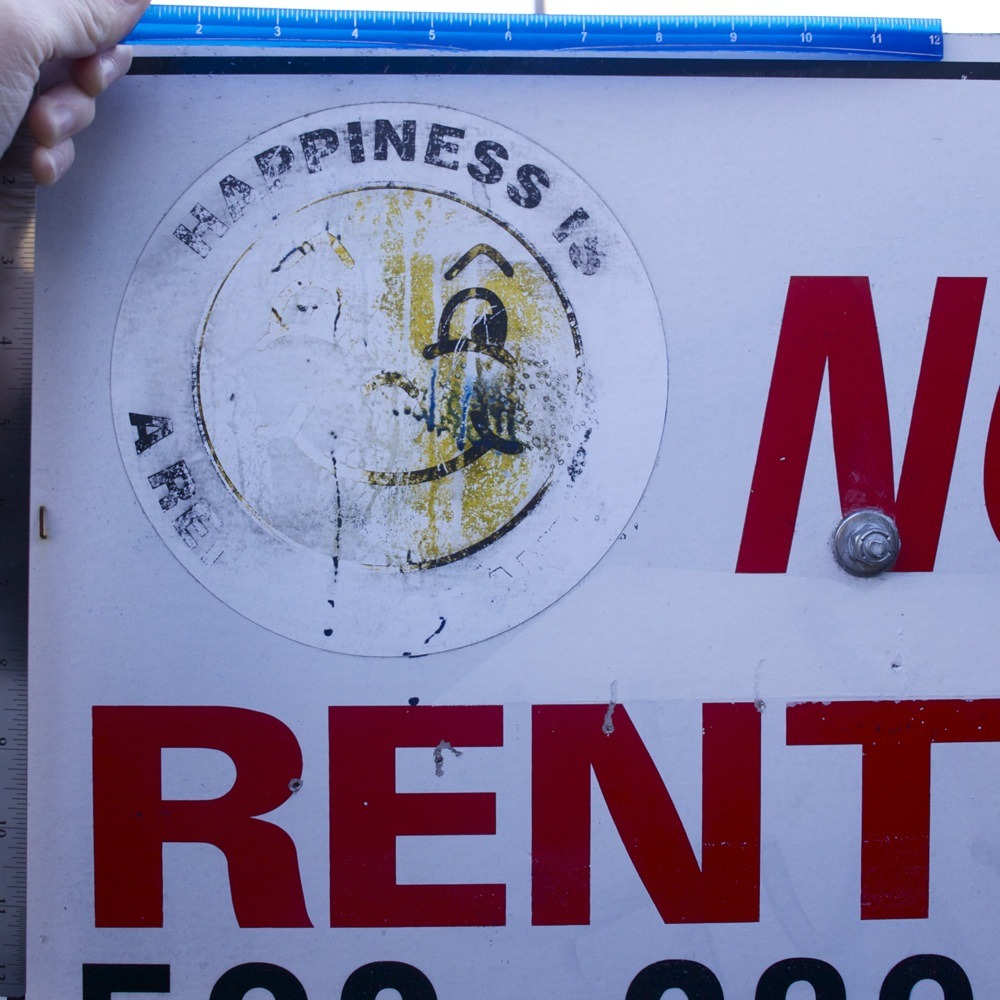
[128,4,943,59]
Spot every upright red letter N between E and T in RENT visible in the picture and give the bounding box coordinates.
[531,704,760,924]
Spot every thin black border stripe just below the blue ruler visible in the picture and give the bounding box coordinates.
[131,55,1000,80]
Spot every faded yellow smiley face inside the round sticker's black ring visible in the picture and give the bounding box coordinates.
[194,186,584,569]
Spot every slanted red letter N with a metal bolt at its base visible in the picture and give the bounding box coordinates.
[736,277,986,573]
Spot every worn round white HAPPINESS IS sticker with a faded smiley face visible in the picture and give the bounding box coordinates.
[113,104,666,655]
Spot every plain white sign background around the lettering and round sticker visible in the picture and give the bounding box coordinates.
[29,58,1000,1000]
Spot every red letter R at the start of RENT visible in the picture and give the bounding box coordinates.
[93,706,312,927]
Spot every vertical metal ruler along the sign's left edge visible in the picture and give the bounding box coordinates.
[0,125,35,997]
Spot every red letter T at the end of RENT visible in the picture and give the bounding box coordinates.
[785,698,1000,920]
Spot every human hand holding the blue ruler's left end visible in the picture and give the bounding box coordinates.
[0,0,149,184]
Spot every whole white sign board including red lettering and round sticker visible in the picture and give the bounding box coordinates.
[29,52,1000,1000]
